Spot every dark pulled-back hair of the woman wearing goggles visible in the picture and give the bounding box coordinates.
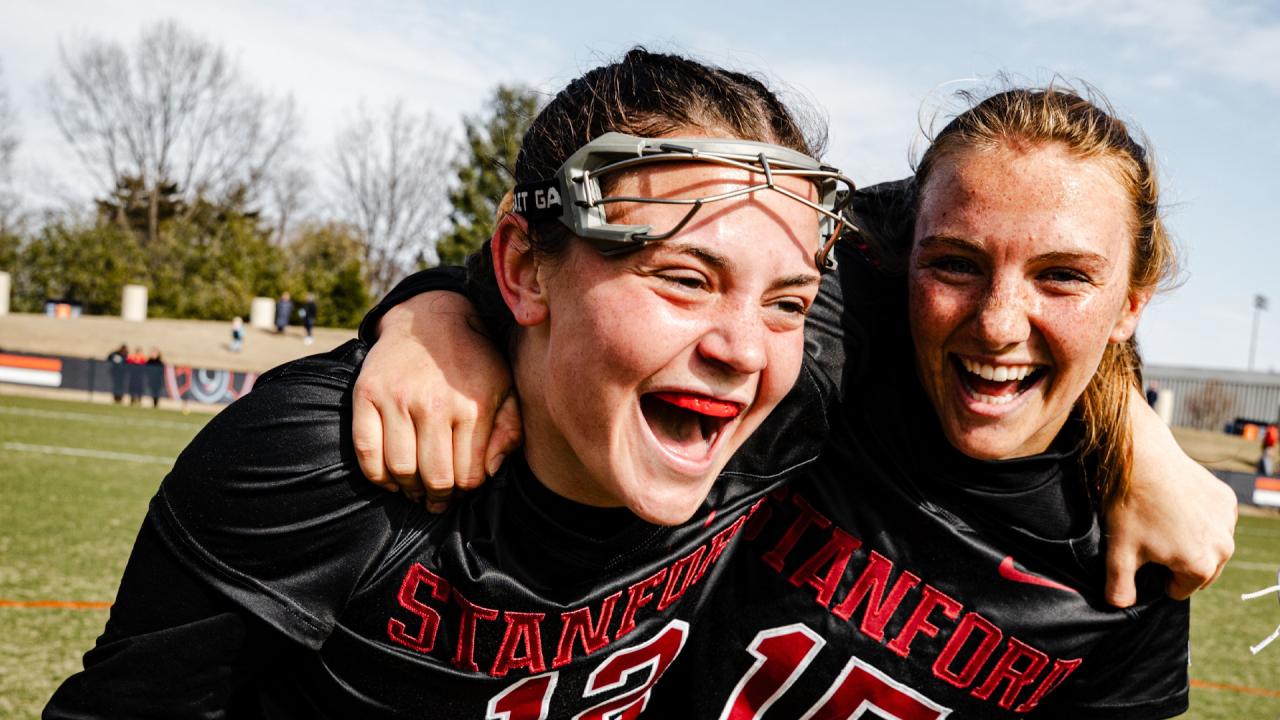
[467,47,826,342]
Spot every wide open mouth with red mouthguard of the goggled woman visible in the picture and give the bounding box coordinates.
[640,392,744,461]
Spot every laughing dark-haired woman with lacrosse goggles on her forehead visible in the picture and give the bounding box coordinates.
[45,51,849,720]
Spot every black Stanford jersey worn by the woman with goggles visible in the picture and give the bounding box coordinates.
[45,333,824,720]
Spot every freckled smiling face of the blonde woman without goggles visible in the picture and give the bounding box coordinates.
[909,143,1149,460]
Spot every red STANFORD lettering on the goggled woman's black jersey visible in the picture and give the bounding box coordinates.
[387,500,764,678]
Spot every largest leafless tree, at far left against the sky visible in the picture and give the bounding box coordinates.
[49,20,298,241]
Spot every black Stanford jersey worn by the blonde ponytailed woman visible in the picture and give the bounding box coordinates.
[652,221,1189,720]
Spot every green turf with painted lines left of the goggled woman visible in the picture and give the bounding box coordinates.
[0,396,210,719]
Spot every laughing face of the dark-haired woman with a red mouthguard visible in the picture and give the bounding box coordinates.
[507,163,819,524]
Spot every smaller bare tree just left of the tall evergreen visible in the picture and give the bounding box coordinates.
[333,101,454,296]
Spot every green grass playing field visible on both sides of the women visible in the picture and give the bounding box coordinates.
[0,396,1280,720]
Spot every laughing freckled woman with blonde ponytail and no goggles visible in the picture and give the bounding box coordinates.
[355,82,1222,719]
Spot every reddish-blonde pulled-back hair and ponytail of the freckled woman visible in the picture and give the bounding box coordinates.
[915,83,1178,506]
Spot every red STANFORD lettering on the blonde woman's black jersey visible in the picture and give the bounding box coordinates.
[746,488,1083,712]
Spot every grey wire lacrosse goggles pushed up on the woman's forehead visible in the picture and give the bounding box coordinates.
[512,132,854,269]
